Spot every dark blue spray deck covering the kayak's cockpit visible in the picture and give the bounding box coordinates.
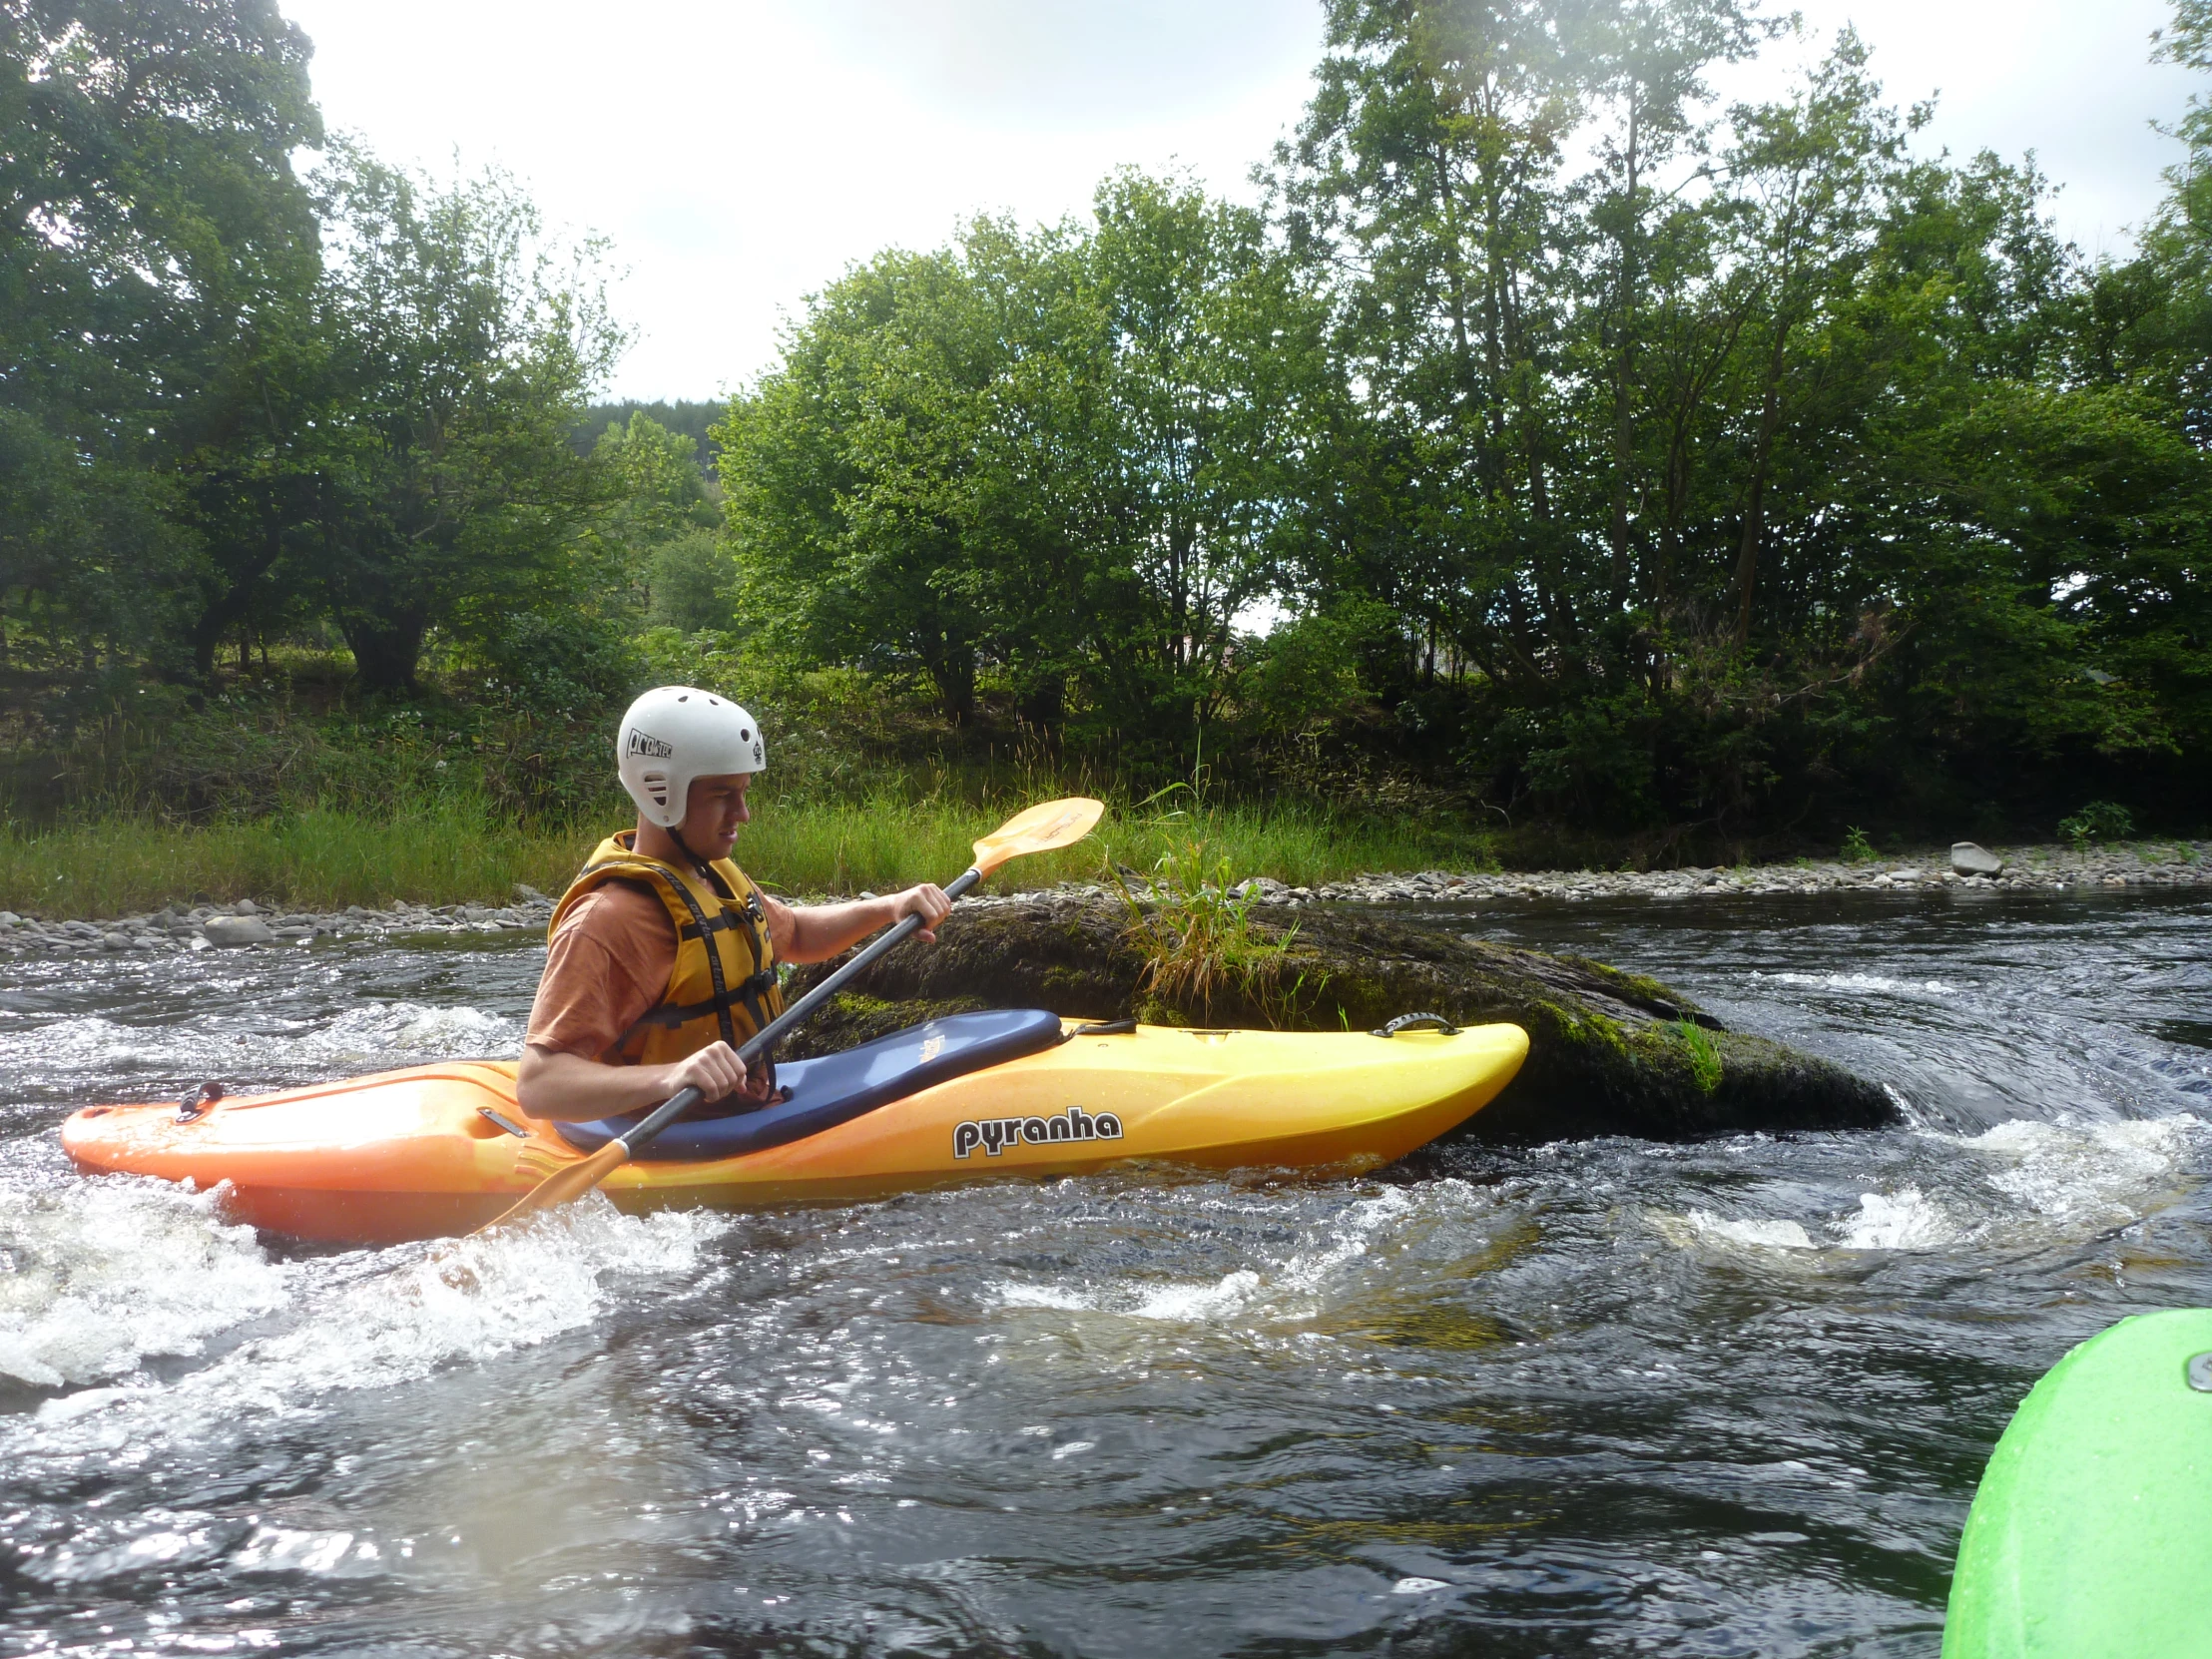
[555,1008,1059,1164]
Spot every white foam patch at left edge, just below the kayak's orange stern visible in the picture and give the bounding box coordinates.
[0,1177,296,1389]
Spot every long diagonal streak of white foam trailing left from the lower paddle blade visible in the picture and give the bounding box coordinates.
[0,1199,728,1453]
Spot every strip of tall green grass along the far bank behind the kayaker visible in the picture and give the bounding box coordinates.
[0,795,1493,918]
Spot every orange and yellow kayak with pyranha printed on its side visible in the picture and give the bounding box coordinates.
[62,1011,1528,1243]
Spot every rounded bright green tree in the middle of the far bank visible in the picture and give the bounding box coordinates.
[717,173,1328,755]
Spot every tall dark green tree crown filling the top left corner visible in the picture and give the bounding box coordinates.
[0,0,320,681]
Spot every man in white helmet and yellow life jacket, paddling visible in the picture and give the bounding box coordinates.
[515,686,951,1119]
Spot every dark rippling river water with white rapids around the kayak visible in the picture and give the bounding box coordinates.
[0,893,2212,1659]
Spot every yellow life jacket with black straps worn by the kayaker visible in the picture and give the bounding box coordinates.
[546,830,783,1066]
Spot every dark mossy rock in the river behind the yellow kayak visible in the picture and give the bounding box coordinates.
[783,895,1896,1141]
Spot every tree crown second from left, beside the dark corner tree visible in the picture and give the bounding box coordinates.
[314,148,622,690]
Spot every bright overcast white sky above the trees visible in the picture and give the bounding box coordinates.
[283,0,2192,398]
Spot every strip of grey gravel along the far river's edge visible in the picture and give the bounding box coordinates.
[0,840,2212,958]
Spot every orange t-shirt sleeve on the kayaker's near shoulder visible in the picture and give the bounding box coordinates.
[522,880,677,1064]
